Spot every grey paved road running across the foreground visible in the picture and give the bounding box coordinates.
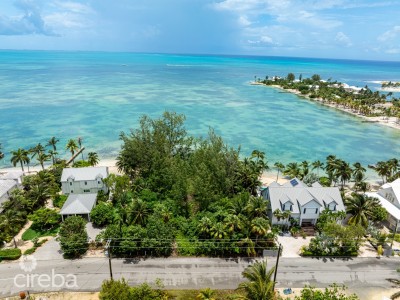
[0,258,400,299]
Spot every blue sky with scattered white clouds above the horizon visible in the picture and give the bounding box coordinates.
[0,0,400,61]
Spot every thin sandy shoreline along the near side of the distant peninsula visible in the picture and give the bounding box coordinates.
[250,82,400,130]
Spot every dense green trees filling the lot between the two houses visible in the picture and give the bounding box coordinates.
[96,112,275,256]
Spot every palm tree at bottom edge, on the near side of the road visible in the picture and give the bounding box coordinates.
[238,261,275,300]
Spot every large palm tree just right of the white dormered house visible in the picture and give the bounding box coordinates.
[345,193,381,228]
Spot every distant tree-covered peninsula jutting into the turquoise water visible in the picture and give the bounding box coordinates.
[258,73,400,118]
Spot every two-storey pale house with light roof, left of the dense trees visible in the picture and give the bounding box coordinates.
[61,167,108,195]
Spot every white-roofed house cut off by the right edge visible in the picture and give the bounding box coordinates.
[365,179,400,229]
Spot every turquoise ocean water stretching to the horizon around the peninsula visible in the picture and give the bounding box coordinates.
[0,51,400,167]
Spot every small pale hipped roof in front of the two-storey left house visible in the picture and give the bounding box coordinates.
[60,194,97,215]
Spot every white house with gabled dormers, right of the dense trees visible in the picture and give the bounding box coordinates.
[261,178,345,226]
